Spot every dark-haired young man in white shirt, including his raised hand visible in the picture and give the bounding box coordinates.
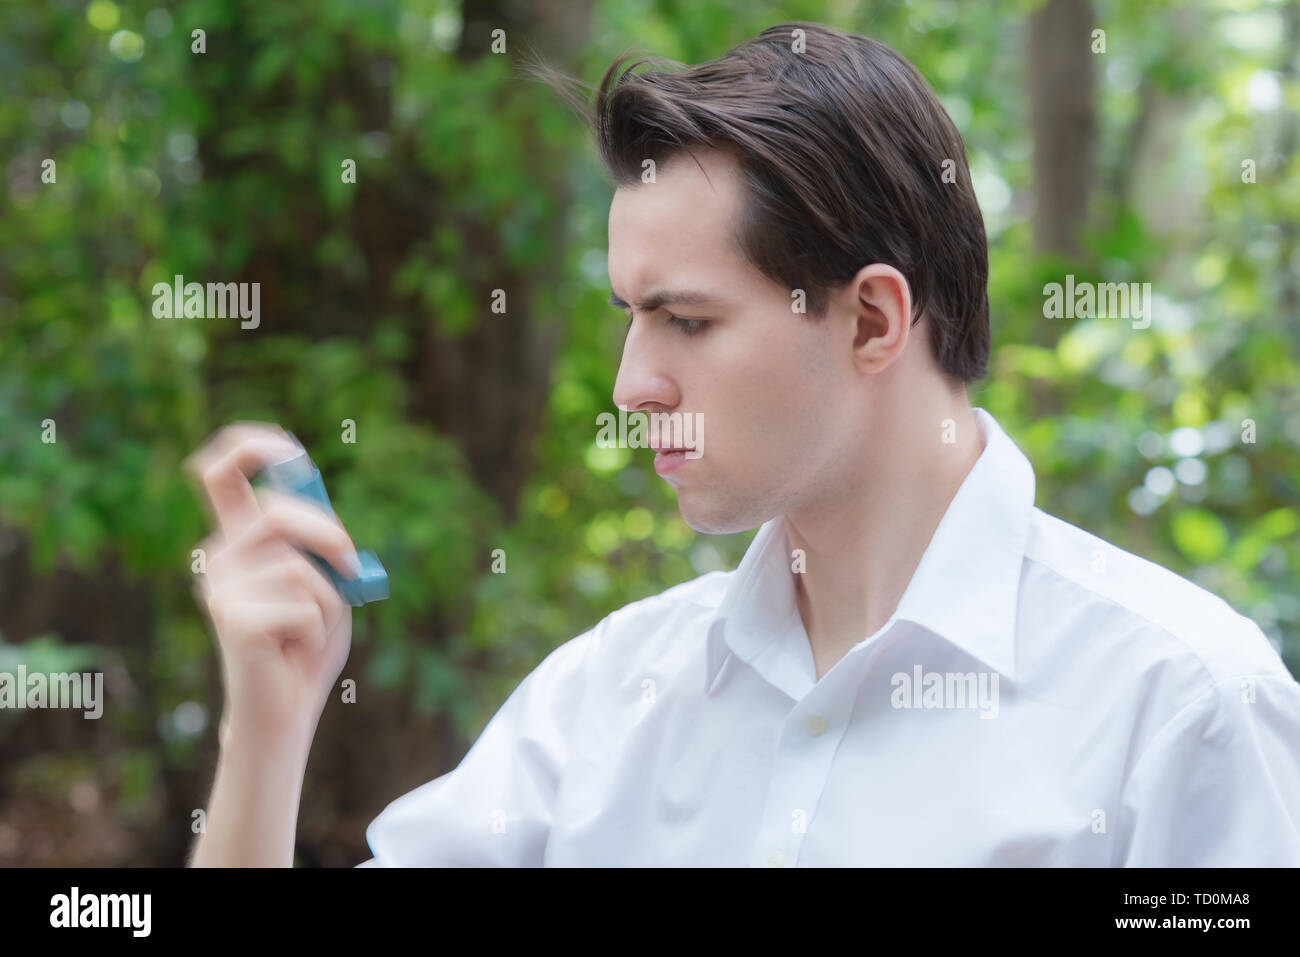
[195,23,1300,866]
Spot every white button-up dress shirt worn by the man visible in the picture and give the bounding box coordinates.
[363,408,1300,866]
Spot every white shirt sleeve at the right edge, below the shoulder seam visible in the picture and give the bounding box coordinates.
[1121,674,1300,867]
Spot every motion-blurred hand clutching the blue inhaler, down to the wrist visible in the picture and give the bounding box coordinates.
[186,423,359,761]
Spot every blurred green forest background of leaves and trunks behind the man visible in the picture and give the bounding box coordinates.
[0,0,1300,866]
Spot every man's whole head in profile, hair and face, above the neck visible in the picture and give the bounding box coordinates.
[527,23,989,533]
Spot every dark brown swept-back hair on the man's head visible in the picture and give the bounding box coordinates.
[528,22,989,384]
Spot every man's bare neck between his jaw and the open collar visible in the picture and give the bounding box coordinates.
[785,393,984,680]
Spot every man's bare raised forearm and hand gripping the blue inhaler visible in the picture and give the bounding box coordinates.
[180,423,360,867]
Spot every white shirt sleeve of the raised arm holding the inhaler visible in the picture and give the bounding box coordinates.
[359,625,599,867]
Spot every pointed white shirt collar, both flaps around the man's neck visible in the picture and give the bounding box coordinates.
[705,407,1035,693]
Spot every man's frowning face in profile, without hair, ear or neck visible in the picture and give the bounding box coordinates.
[608,151,853,534]
